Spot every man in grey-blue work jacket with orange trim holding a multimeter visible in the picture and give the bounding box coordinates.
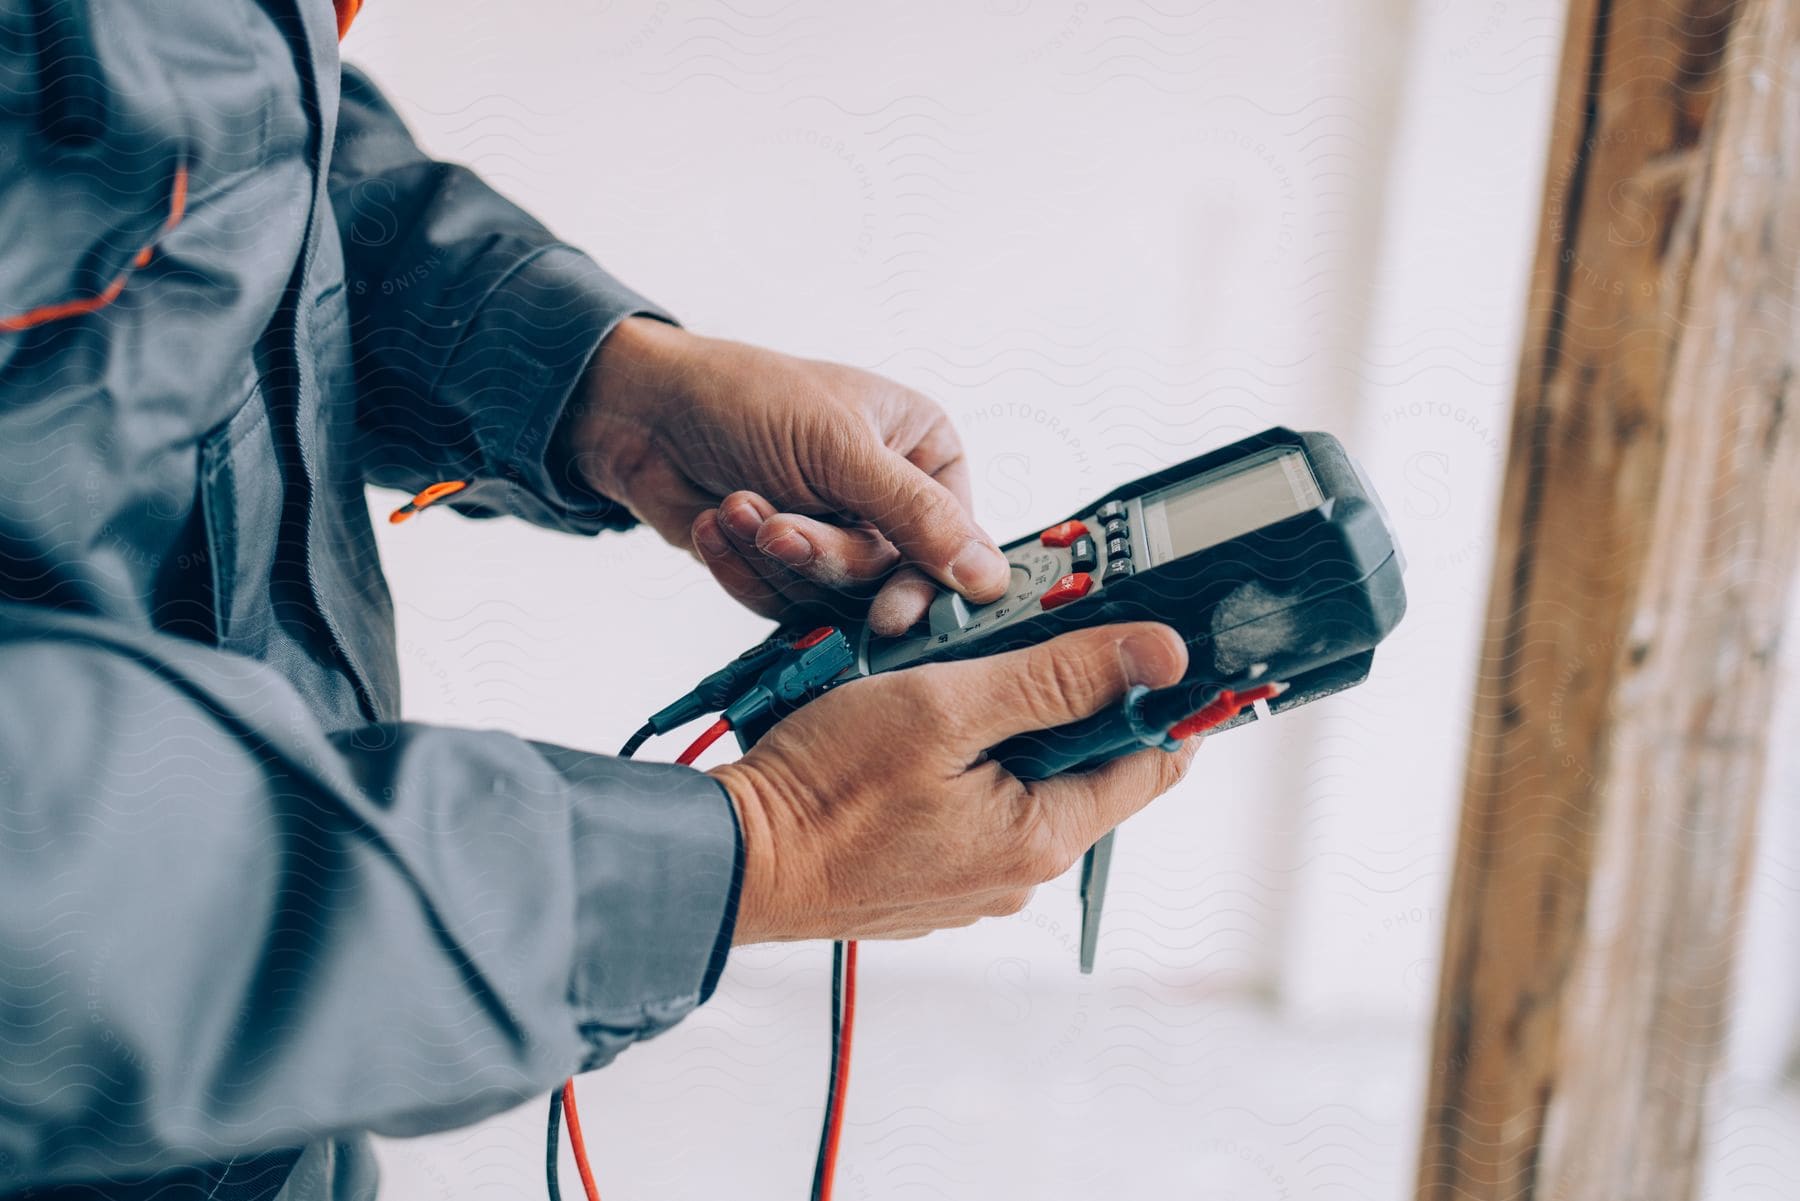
[0,0,1186,1201]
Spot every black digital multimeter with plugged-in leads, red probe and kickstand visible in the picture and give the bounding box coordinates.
[680,429,1406,971]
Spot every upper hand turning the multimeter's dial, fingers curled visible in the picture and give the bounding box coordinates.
[569,317,1008,634]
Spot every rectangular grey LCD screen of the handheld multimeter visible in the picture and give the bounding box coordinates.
[1143,450,1325,567]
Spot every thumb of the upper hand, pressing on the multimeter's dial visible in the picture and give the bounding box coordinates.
[814,438,1012,603]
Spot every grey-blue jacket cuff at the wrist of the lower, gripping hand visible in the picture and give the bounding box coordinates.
[538,747,743,1071]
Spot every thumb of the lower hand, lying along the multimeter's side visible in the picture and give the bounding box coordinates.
[920,621,1188,747]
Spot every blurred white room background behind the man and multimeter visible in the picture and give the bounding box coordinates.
[346,0,1796,1197]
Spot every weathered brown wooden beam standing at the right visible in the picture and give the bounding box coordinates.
[1418,0,1800,1201]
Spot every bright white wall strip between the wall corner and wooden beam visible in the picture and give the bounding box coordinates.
[1283,2,1562,1019]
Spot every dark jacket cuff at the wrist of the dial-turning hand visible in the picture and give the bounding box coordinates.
[436,243,675,533]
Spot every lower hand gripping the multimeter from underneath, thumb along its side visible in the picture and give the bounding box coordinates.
[713,623,1199,945]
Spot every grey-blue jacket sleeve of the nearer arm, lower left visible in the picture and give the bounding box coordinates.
[0,603,740,1192]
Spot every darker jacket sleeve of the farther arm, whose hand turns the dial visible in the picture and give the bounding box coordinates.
[329,67,670,533]
